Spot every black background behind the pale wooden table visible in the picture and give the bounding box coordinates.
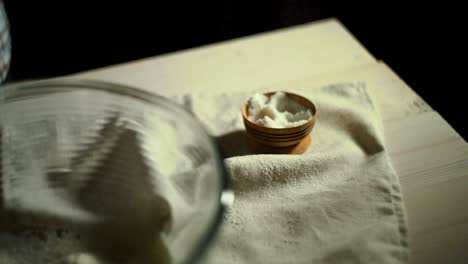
[4,0,468,139]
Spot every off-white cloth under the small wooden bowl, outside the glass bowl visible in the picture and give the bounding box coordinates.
[181,83,408,264]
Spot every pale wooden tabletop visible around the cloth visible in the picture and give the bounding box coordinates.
[71,19,468,263]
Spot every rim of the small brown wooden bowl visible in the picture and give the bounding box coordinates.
[242,91,318,135]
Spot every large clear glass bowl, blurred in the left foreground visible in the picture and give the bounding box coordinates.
[0,79,230,263]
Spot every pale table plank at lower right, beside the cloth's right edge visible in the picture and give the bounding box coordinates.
[385,111,468,263]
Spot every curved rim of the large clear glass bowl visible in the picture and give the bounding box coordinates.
[0,78,233,263]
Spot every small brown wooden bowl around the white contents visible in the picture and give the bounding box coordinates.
[242,92,317,152]
